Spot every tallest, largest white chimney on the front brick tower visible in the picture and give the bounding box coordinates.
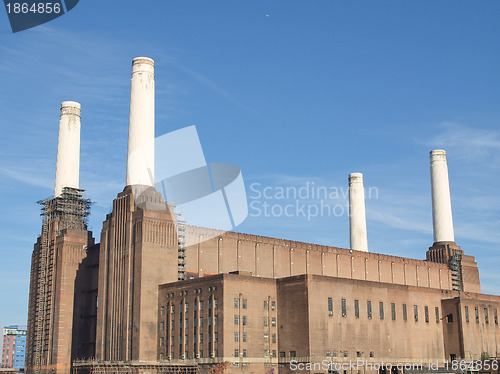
[127,57,155,186]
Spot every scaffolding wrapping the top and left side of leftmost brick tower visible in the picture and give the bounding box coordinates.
[30,187,92,374]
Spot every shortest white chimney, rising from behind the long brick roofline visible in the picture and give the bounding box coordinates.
[349,173,368,252]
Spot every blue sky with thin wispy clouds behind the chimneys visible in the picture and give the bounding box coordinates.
[0,0,500,324]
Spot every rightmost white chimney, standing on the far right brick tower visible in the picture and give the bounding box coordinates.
[430,149,455,243]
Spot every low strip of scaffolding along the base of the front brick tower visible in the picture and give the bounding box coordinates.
[73,360,199,374]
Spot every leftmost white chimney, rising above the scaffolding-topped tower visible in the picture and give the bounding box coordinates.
[54,101,80,197]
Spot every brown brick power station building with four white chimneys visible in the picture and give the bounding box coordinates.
[26,57,500,374]
